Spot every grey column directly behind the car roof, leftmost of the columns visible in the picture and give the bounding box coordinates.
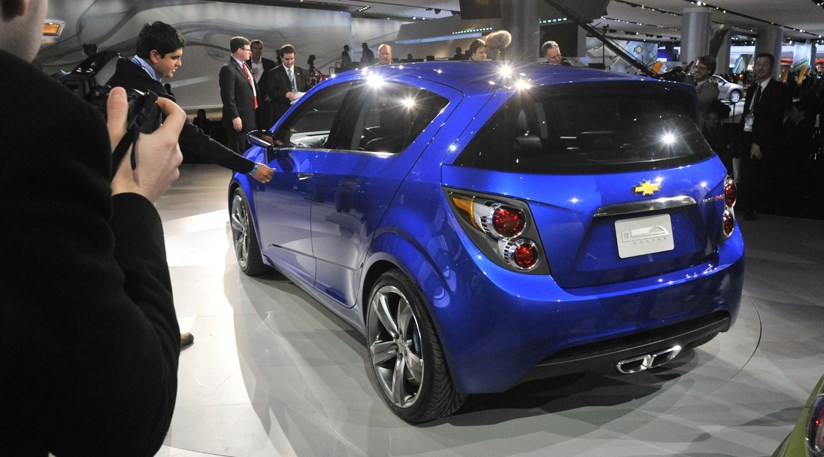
[501,0,541,63]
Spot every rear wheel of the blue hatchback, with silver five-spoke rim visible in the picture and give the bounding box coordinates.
[366,270,466,423]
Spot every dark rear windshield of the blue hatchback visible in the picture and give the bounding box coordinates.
[455,83,712,174]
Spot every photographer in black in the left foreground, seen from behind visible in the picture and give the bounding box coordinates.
[0,0,186,456]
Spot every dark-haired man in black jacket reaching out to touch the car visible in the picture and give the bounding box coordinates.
[104,21,274,183]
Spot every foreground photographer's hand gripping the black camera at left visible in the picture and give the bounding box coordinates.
[106,87,186,202]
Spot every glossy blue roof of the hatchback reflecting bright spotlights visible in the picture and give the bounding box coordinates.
[338,61,663,95]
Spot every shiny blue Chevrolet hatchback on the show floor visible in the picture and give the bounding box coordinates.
[229,62,744,422]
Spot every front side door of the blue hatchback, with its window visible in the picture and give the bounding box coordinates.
[255,83,351,284]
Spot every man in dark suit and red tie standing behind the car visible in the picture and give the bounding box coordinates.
[219,36,258,154]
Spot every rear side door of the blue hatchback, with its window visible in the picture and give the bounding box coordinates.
[311,82,457,307]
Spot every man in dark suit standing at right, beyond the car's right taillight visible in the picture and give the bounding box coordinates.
[739,53,792,219]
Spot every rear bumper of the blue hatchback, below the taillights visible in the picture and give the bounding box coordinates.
[430,233,744,394]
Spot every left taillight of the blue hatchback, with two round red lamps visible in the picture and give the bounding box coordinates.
[448,191,548,272]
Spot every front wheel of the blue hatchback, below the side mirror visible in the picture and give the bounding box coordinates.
[229,187,272,276]
